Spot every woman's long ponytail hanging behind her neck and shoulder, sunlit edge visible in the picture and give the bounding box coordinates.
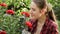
[47,3,59,33]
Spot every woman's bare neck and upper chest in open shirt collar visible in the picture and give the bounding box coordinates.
[34,15,46,34]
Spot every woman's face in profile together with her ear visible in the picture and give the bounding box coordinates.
[30,2,46,19]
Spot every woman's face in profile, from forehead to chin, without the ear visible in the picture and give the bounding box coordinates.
[30,2,41,19]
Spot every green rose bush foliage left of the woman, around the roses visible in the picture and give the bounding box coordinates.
[0,0,30,34]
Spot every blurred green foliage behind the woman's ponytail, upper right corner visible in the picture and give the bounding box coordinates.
[48,0,60,20]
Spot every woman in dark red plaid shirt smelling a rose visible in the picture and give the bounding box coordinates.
[22,0,58,34]
